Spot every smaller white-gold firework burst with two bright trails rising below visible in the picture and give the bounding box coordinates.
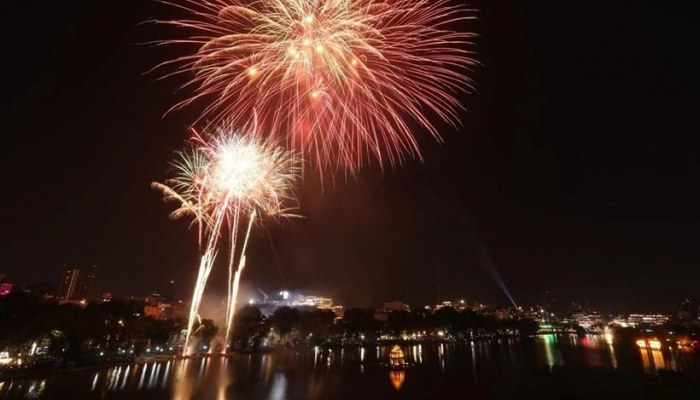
[153,129,298,354]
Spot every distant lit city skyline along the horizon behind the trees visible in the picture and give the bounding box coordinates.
[0,264,700,316]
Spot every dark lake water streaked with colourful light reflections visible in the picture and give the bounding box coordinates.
[0,335,700,400]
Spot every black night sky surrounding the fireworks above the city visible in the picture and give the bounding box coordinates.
[0,0,700,312]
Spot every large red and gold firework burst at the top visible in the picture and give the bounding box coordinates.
[156,0,475,171]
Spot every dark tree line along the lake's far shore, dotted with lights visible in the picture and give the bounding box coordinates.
[0,293,539,361]
